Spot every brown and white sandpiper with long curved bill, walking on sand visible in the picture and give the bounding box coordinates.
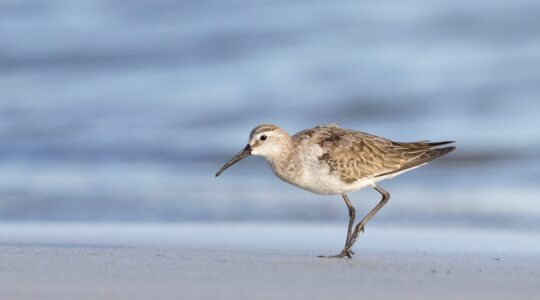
[216,124,455,258]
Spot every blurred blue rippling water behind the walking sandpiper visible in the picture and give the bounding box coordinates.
[0,0,540,230]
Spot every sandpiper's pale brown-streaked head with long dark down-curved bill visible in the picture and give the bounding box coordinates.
[216,124,291,177]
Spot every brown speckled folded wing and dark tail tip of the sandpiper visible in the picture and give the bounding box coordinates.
[293,125,454,183]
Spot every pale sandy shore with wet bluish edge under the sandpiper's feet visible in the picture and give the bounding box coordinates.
[0,223,540,299]
